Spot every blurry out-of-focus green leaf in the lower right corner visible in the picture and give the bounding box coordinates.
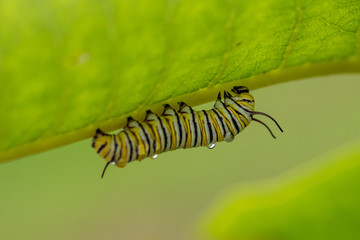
[201,141,360,239]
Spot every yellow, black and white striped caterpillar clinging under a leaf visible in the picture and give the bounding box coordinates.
[92,86,283,177]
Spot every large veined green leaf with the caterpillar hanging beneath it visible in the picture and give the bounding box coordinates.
[0,0,360,161]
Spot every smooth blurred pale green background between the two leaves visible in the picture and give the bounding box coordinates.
[0,75,360,240]
